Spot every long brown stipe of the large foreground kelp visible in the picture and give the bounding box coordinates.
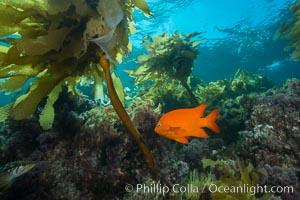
[97,53,157,179]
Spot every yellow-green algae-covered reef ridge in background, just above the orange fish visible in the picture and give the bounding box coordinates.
[137,69,274,112]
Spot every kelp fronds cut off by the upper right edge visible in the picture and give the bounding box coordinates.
[275,0,300,60]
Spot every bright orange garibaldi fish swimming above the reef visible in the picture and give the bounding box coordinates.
[155,104,220,144]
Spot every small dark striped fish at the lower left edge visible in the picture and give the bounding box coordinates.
[0,161,36,191]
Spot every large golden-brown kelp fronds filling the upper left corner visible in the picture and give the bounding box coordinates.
[0,0,151,129]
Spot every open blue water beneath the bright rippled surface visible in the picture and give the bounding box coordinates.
[118,0,300,87]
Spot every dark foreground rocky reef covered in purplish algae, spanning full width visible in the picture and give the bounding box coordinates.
[0,77,300,200]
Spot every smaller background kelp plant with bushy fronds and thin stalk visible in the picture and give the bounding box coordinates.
[127,33,200,104]
